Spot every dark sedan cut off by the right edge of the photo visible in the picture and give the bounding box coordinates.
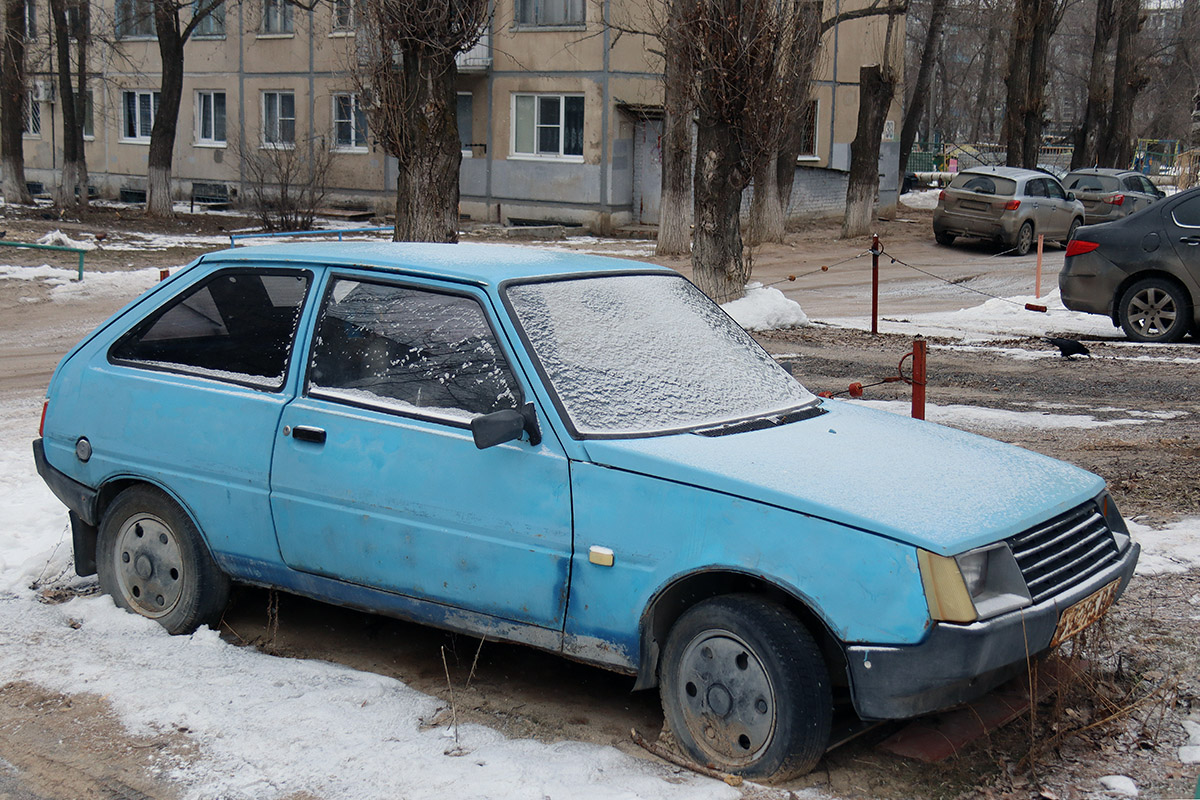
[1058,188,1200,342]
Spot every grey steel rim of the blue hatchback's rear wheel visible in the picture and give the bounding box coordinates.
[113,513,184,619]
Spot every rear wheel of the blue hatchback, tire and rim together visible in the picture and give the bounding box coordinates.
[96,486,229,633]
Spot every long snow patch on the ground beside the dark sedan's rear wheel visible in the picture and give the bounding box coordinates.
[824,289,1124,342]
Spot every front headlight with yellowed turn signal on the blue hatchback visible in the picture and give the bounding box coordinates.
[917,542,1030,622]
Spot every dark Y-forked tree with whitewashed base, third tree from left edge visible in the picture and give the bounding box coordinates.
[139,0,224,217]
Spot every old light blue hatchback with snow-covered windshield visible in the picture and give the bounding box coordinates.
[34,243,1138,777]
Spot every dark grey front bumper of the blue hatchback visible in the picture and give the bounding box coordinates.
[846,543,1140,720]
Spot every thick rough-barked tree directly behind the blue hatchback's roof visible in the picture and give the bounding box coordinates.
[355,0,490,242]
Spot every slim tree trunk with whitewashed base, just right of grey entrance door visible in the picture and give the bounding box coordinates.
[654,2,695,255]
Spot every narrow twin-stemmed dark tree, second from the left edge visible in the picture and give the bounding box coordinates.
[50,0,91,206]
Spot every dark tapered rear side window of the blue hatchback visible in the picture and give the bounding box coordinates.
[108,270,311,391]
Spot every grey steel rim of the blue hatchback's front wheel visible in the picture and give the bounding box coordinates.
[676,631,776,764]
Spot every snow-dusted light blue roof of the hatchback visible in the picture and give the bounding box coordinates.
[200,241,674,285]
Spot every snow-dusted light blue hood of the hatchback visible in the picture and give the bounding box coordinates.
[576,401,1104,555]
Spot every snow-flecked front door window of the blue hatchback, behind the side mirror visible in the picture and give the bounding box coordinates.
[308,278,521,421]
